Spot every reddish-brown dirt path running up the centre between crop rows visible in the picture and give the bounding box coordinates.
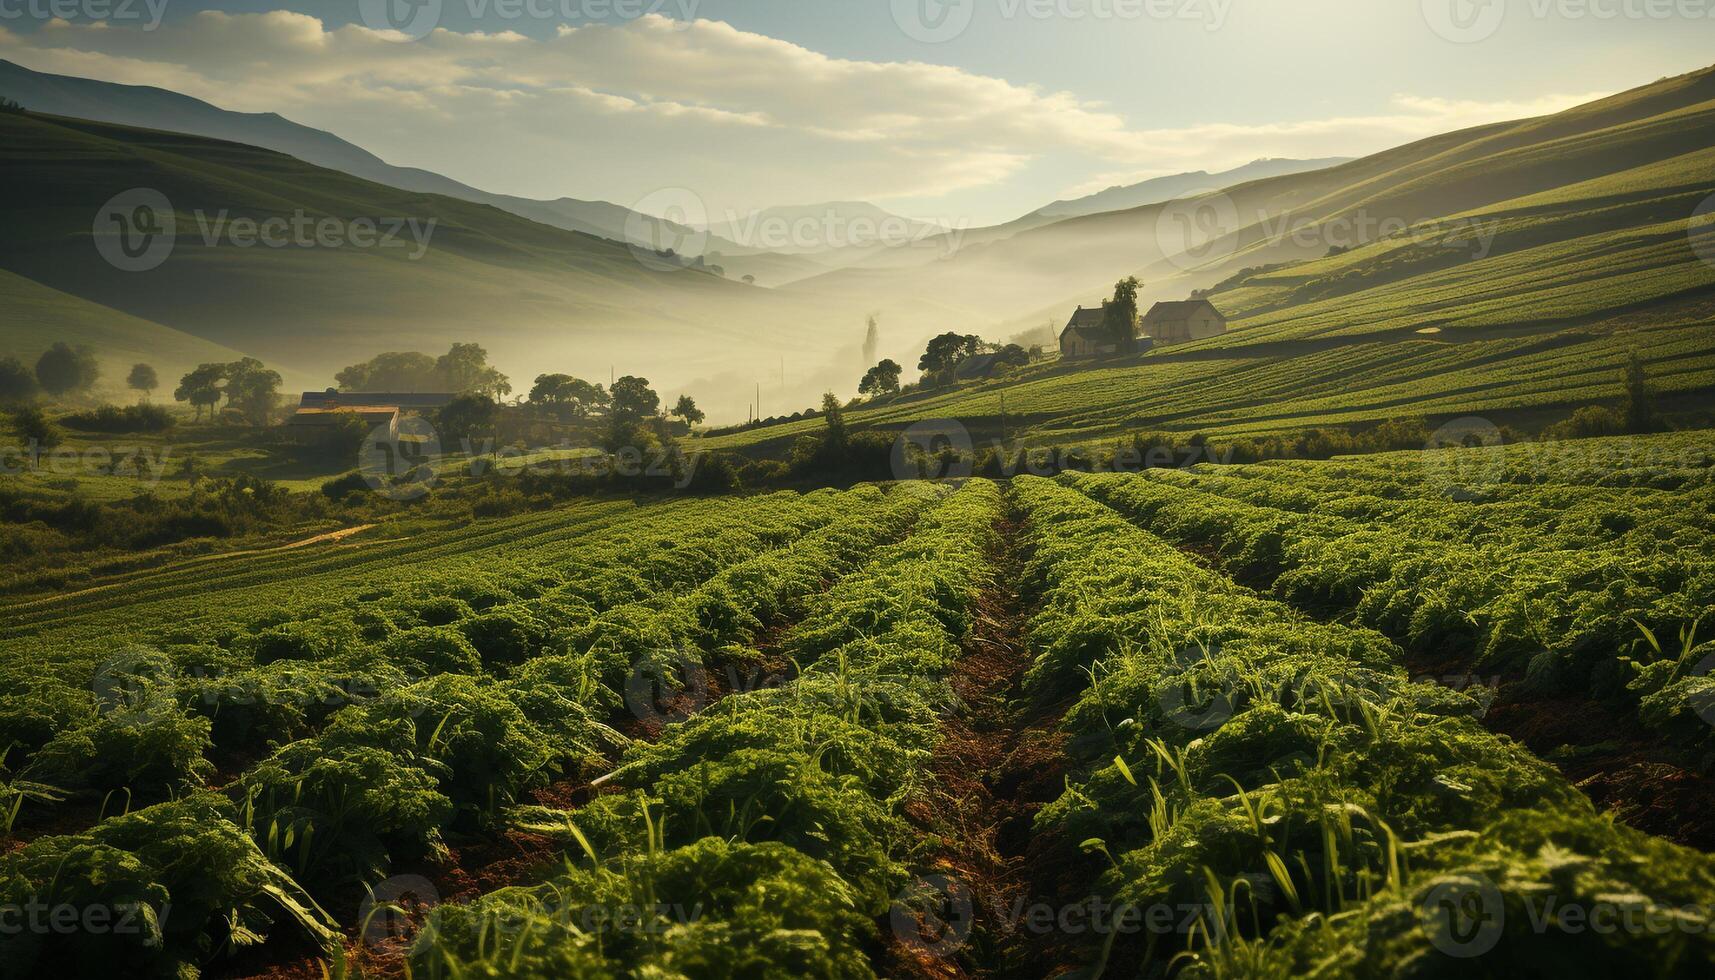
[882,501,1065,978]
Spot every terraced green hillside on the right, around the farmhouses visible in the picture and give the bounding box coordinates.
[710,70,1715,451]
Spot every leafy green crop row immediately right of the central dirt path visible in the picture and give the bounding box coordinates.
[1014,477,1715,978]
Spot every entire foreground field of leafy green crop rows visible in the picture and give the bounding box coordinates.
[0,433,1715,978]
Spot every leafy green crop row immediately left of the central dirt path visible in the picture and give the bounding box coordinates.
[412,481,1000,977]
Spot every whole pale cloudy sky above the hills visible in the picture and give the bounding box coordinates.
[0,0,1715,227]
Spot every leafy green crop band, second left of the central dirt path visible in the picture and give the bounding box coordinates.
[0,487,935,968]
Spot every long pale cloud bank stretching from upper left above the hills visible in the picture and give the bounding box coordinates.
[0,10,1147,213]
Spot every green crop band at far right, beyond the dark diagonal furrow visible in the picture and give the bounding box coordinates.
[1070,474,1715,748]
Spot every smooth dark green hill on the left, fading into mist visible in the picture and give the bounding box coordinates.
[0,115,821,413]
